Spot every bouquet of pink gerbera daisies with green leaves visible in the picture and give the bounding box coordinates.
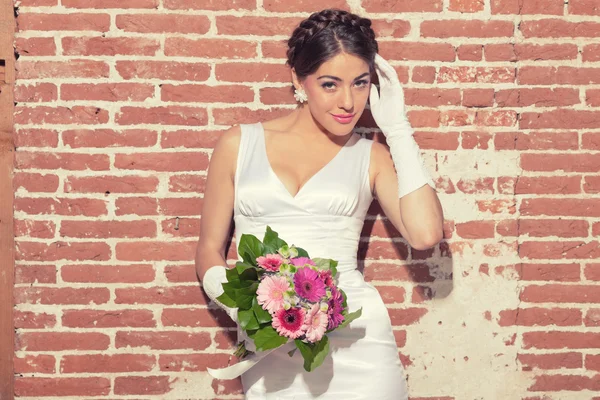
[218,226,362,371]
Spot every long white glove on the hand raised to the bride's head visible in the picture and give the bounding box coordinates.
[369,54,435,197]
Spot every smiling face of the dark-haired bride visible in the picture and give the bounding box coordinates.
[294,53,371,136]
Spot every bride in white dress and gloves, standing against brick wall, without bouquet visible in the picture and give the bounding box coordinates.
[196,10,443,400]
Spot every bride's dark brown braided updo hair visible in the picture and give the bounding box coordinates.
[286,9,378,80]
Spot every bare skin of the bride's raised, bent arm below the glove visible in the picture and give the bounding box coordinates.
[371,142,444,250]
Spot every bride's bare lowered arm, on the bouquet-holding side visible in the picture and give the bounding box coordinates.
[195,126,241,281]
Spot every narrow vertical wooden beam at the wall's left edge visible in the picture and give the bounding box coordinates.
[0,0,15,400]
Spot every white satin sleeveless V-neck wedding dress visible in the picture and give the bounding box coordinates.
[234,123,408,400]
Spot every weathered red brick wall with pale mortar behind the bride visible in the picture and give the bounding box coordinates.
[14,0,600,400]
